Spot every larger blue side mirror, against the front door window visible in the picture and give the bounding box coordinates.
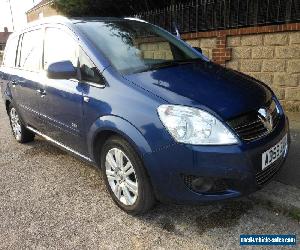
[47,61,77,79]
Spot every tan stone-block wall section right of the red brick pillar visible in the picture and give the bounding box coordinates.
[226,31,300,111]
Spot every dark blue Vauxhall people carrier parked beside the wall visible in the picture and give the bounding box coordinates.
[0,17,290,214]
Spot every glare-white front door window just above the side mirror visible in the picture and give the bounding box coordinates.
[44,28,78,69]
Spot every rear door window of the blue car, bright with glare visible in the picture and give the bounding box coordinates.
[19,30,43,71]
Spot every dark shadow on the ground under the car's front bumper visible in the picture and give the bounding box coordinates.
[138,198,254,236]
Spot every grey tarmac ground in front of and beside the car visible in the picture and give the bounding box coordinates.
[0,98,300,249]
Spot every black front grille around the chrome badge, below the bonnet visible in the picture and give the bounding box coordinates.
[228,100,280,141]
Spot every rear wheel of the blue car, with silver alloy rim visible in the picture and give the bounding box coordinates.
[8,104,35,143]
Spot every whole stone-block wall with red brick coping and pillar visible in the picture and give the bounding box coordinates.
[182,23,300,112]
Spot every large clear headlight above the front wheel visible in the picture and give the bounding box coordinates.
[157,104,238,145]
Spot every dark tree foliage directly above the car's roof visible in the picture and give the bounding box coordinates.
[54,0,179,17]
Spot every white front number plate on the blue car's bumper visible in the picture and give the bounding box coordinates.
[262,135,287,170]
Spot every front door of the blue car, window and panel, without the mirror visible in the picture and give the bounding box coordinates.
[38,26,86,153]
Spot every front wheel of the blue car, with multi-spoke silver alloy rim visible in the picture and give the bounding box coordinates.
[101,136,155,215]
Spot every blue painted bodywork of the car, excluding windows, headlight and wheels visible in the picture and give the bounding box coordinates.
[0,19,289,203]
